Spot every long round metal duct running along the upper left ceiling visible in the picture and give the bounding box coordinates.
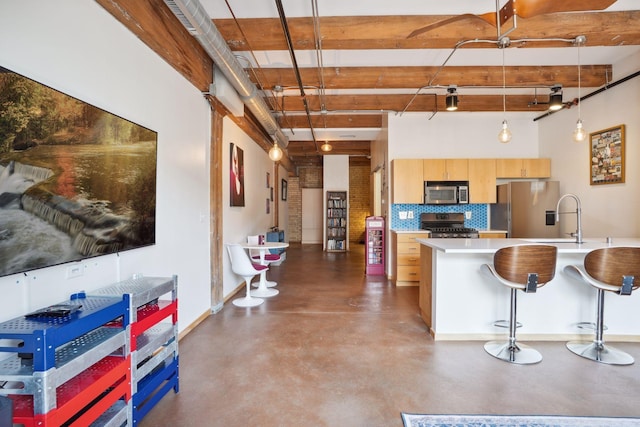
[164,0,289,147]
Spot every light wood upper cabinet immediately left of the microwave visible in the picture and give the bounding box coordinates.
[391,159,424,204]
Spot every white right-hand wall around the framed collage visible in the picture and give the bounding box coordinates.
[538,51,640,237]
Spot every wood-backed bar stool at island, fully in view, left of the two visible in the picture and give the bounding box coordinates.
[482,245,558,365]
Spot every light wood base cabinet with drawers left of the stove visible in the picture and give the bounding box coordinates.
[391,233,428,286]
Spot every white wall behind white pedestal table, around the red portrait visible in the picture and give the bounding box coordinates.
[222,117,288,298]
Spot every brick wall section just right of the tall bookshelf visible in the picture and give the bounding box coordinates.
[349,165,371,244]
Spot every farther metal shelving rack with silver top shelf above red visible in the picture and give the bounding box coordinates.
[93,276,179,426]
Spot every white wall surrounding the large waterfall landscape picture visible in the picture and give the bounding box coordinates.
[0,0,211,330]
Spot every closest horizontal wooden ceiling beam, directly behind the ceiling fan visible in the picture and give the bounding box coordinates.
[214,10,640,51]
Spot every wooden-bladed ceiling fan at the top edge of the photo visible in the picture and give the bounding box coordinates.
[407,0,616,38]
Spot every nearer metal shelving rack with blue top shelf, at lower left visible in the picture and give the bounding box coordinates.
[0,293,131,427]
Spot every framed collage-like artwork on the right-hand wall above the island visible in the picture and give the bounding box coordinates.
[589,125,624,185]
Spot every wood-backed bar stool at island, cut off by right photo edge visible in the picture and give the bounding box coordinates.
[564,247,640,365]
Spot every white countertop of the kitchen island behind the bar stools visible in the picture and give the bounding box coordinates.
[416,237,640,254]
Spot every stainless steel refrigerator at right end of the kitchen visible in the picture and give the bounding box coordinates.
[490,181,560,237]
